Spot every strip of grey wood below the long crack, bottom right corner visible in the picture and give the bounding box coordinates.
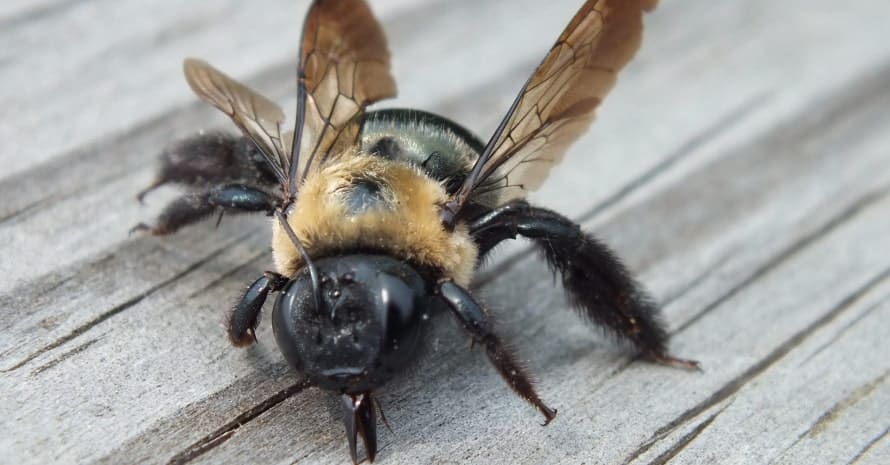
[632,273,890,464]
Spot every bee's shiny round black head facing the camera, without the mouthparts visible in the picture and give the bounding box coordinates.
[272,255,428,393]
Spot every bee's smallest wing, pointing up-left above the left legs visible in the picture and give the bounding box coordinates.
[183,58,289,185]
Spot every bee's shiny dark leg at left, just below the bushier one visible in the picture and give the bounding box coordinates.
[131,184,277,236]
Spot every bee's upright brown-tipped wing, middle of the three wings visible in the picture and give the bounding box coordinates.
[289,0,396,192]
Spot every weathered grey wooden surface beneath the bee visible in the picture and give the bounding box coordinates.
[0,0,890,464]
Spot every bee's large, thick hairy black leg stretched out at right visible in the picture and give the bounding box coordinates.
[470,201,699,369]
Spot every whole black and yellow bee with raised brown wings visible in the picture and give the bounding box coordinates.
[134,0,698,463]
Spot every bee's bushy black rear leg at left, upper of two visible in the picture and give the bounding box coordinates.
[137,132,277,202]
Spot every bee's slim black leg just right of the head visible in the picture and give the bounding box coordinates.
[436,281,556,425]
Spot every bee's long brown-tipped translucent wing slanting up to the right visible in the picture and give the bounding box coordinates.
[448,0,657,218]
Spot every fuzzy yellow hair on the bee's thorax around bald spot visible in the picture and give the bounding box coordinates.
[272,154,478,286]
